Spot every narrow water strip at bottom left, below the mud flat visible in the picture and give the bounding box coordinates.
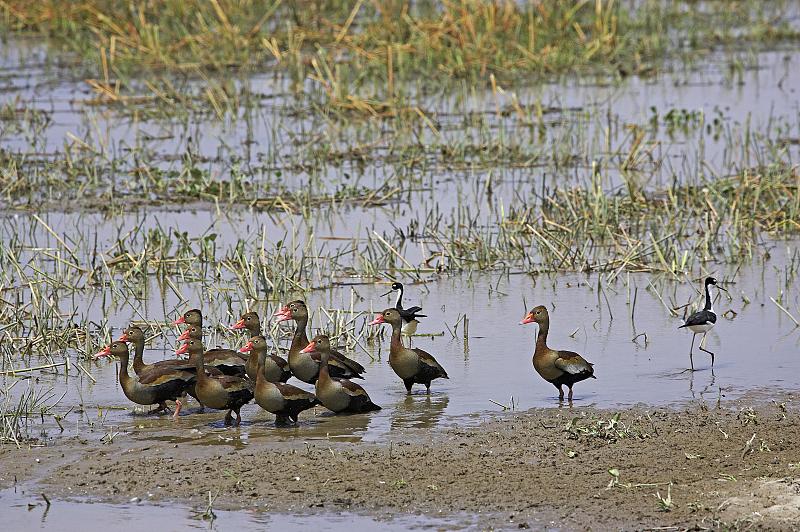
[0,488,468,532]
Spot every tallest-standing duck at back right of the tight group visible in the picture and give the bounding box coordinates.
[275,300,365,384]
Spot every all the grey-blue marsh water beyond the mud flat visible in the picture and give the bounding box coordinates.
[0,14,800,456]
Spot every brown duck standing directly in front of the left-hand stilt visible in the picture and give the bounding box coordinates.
[370,308,450,393]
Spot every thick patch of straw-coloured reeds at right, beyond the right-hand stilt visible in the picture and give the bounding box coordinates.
[412,164,800,274]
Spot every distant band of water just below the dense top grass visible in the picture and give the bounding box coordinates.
[0,34,800,210]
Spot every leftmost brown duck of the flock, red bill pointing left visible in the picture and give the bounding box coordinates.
[94,342,195,418]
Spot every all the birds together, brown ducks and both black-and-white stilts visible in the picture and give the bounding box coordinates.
[95,277,717,425]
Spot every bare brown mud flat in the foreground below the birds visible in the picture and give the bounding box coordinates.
[0,402,800,530]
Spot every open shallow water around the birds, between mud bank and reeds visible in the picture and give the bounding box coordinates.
[0,243,800,447]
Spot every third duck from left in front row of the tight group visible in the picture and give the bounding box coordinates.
[241,336,319,425]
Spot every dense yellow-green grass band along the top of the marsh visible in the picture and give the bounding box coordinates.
[0,0,798,115]
